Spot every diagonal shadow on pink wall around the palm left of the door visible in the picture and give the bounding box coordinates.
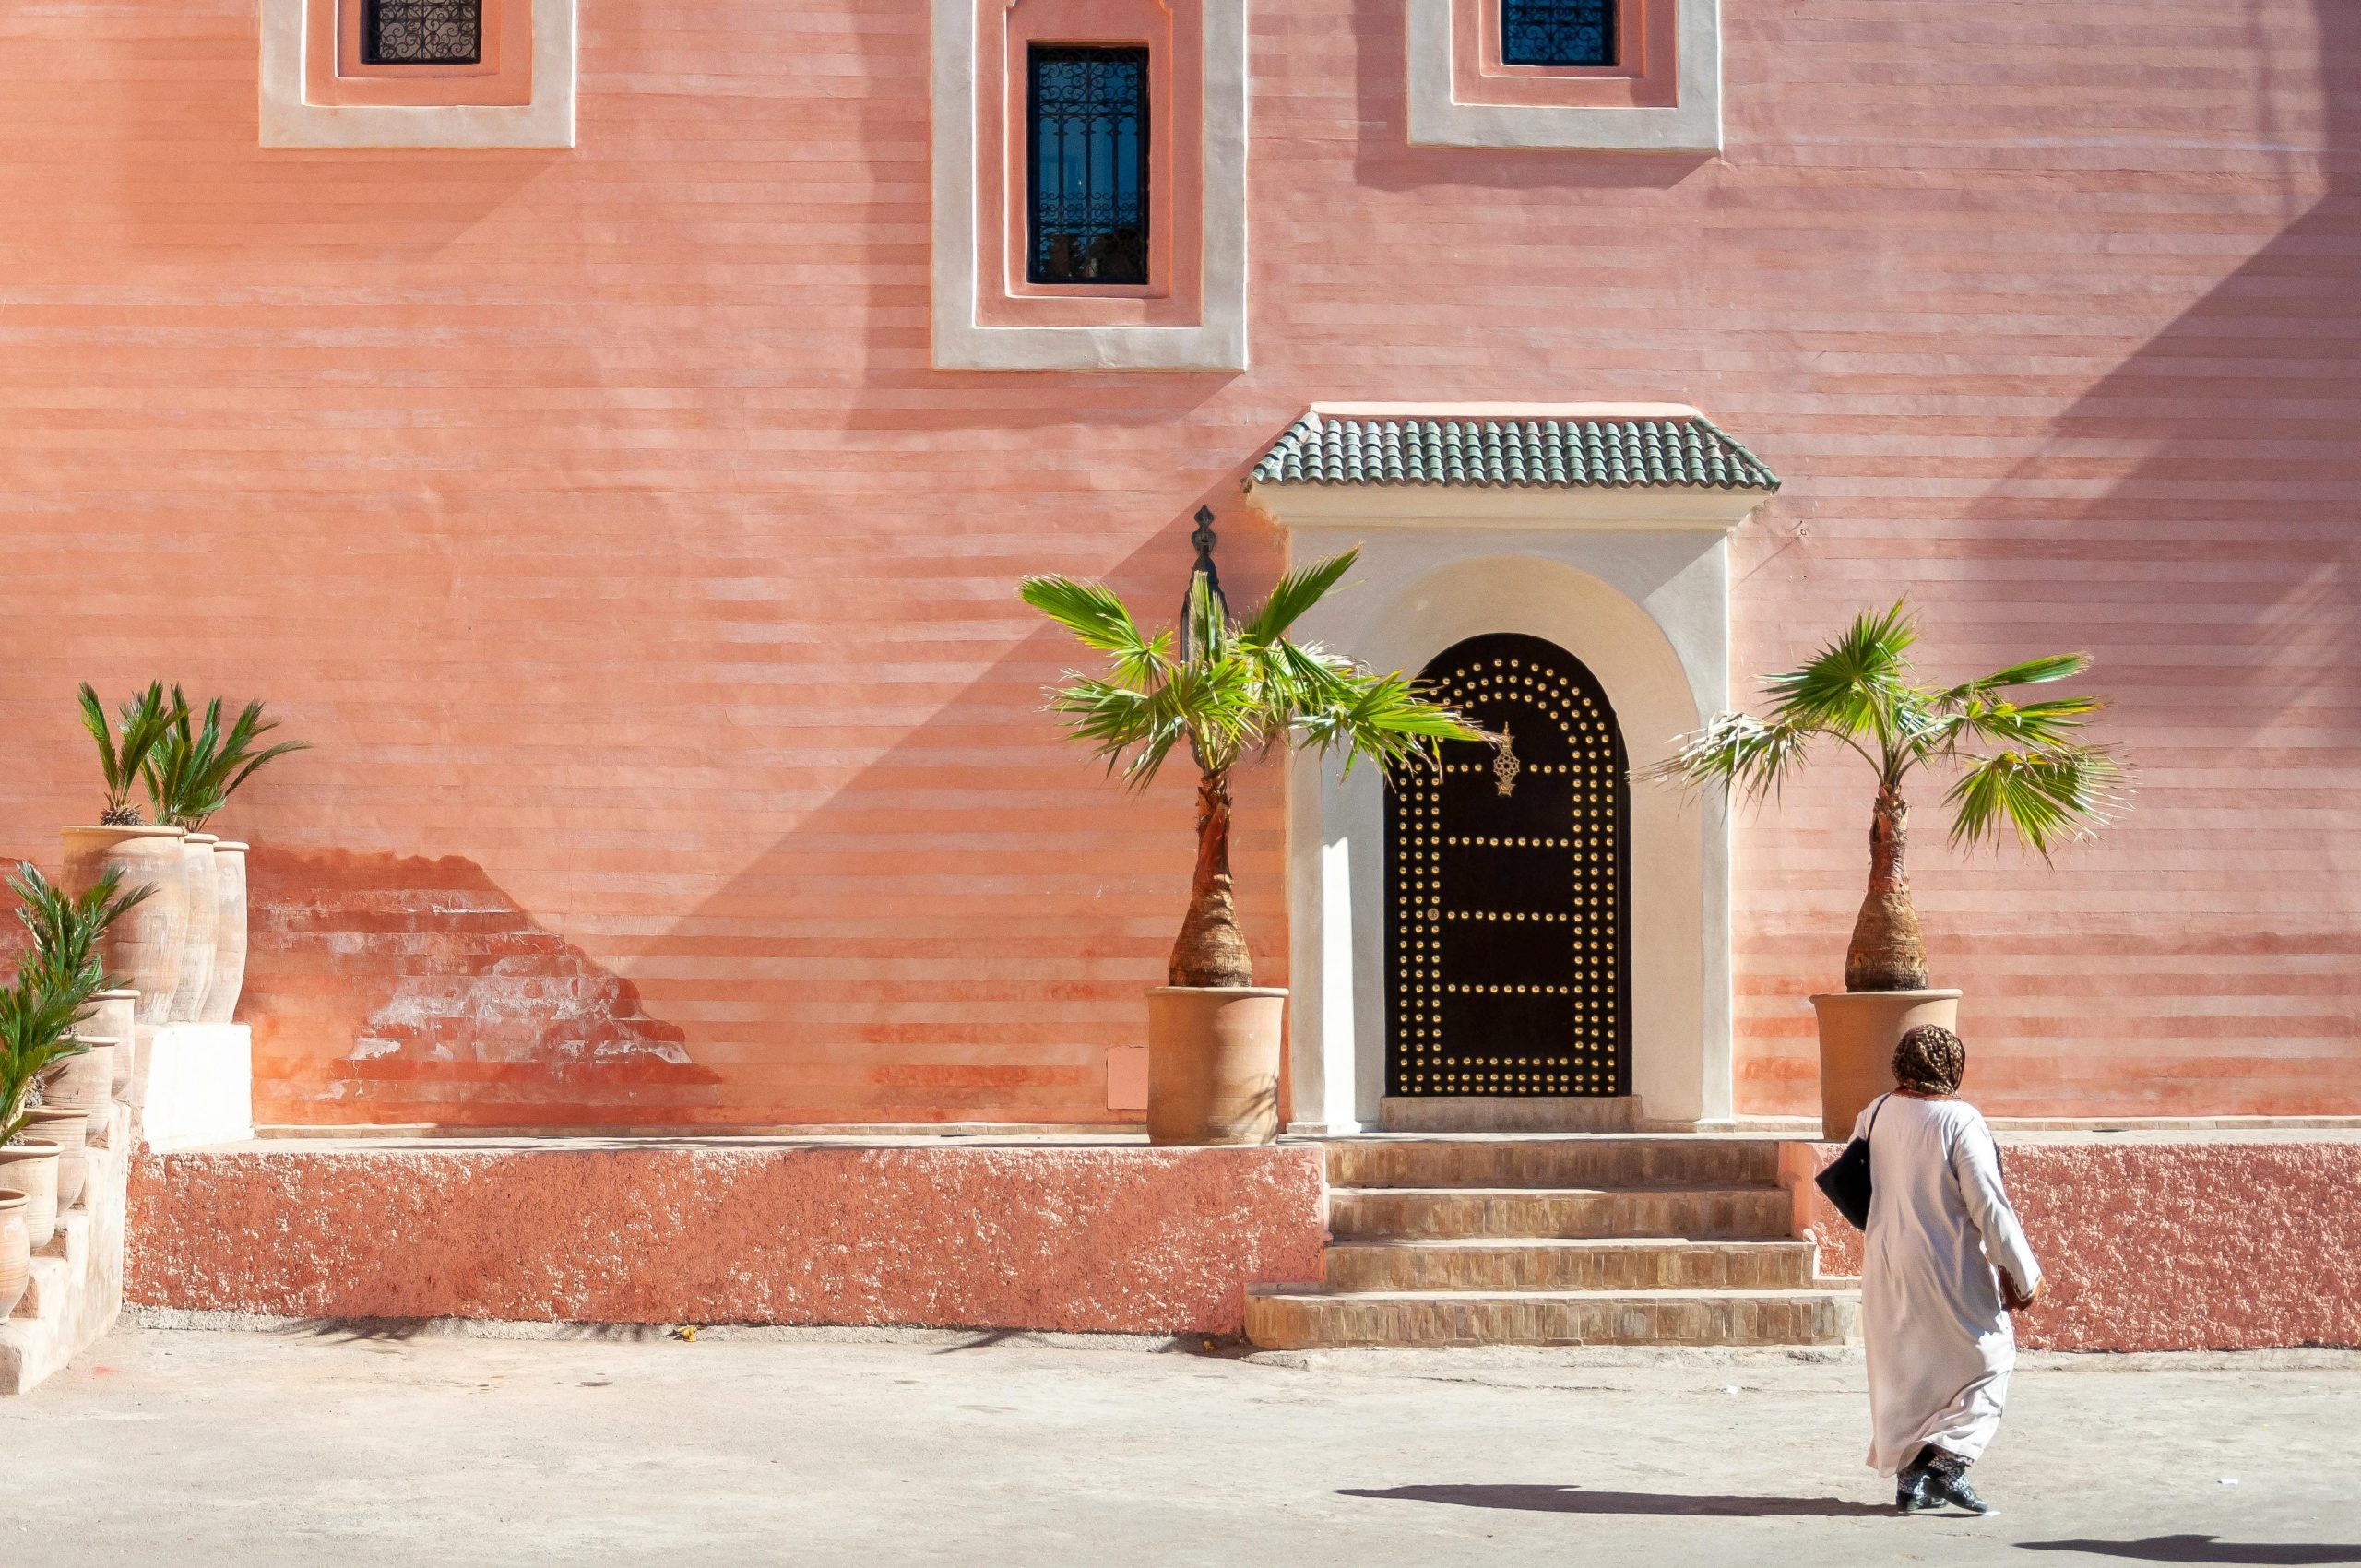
[631,496,1287,1124]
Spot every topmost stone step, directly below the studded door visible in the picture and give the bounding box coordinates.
[1327,1135,1780,1188]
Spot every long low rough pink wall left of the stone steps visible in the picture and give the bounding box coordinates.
[125,1143,1324,1335]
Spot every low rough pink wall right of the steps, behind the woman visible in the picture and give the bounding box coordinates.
[1811,1135,2361,1350]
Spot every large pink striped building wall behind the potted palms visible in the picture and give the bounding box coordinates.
[0,0,2361,1124]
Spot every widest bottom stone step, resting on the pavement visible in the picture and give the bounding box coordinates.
[1247,1285,1860,1350]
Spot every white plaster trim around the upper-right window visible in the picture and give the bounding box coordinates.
[1405,0,1721,153]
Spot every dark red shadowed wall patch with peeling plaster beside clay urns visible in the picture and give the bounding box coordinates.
[241,848,720,1126]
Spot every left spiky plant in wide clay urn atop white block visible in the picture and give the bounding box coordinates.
[62,683,189,1023]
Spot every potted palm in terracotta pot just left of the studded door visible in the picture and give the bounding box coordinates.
[1022,533,1485,1143]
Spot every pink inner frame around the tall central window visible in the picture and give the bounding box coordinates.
[975,0,1204,326]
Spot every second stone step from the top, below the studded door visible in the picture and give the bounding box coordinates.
[1329,1188,1795,1242]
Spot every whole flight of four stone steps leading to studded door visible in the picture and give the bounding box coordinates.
[1247,1134,1858,1350]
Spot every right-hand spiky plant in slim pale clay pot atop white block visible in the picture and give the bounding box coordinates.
[142,687,307,1023]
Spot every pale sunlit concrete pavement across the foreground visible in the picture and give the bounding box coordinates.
[0,1329,2361,1568]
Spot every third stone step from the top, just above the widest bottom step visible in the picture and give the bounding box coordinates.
[1327,1238,1816,1291]
